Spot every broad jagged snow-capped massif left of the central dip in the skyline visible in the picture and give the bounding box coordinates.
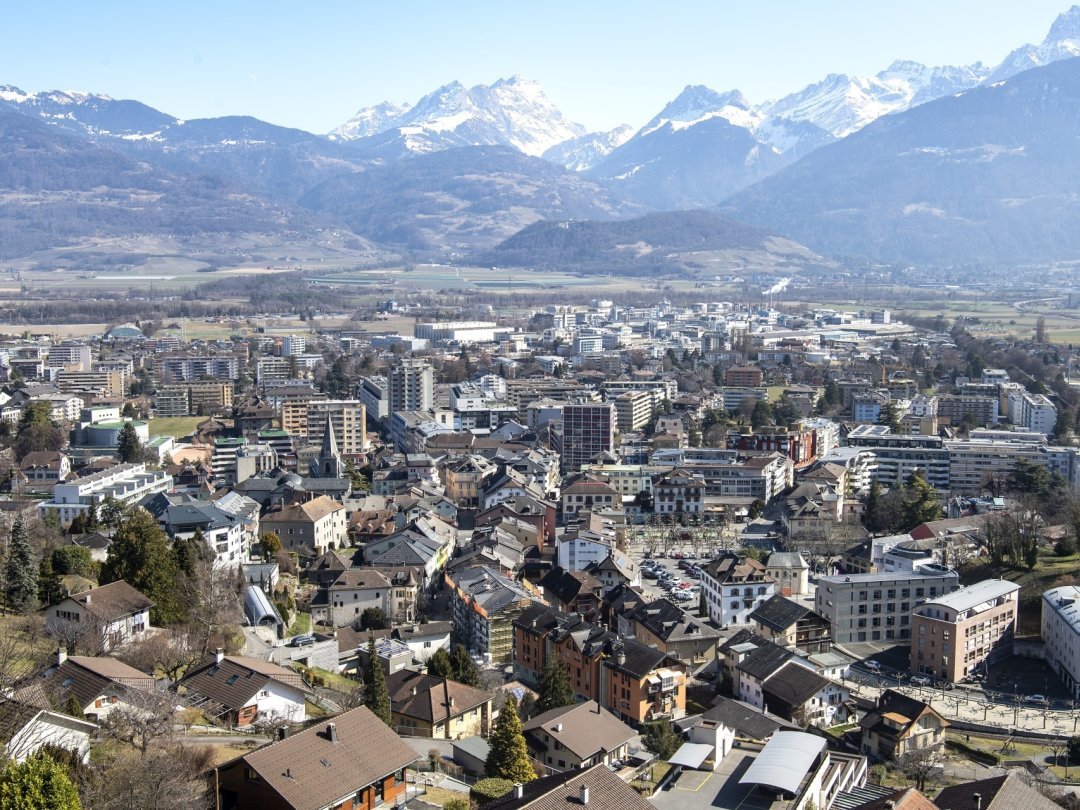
[330,76,585,157]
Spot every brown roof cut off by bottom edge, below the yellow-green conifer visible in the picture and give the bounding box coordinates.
[485,765,656,810]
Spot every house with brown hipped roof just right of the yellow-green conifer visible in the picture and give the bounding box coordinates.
[524,700,637,773]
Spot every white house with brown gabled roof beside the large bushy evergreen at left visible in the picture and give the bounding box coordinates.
[45,580,154,652]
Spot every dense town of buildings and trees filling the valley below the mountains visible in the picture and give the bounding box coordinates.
[0,294,1080,810]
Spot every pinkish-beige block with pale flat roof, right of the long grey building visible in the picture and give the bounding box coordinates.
[910,579,1020,684]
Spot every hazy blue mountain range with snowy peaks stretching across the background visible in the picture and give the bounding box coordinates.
[0,6,1080,264]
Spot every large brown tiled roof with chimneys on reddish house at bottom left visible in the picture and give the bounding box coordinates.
[232,706,419,810]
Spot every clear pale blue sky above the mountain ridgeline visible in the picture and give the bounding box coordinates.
[0,0,1068,133]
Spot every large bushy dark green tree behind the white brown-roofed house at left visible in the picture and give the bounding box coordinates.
[102,509,186,624]
